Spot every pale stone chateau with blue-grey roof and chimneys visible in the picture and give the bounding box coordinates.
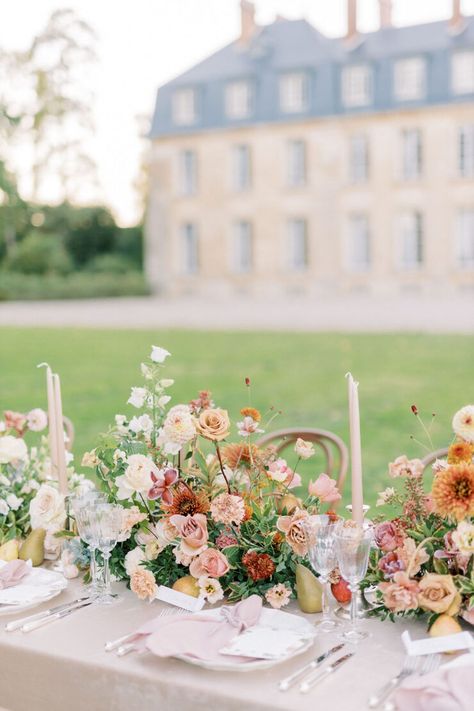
[146,0,474,295]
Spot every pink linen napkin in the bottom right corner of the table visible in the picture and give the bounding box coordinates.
[395,654,474,711]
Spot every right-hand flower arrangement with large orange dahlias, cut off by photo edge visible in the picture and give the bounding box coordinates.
[365,405,474,634]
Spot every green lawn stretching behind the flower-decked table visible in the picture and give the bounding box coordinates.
[0,328,474,504]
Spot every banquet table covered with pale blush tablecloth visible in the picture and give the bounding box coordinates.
[0,580,425,711]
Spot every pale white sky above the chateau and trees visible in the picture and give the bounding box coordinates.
[0,0,474,224]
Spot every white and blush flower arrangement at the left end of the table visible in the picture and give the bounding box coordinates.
[0,408,94,572]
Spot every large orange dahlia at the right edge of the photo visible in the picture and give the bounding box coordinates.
[431,463,474,521]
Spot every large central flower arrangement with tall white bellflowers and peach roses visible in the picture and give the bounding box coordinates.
[82,346,340,608]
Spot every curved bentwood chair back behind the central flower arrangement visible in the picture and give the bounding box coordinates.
[257,427,349,508]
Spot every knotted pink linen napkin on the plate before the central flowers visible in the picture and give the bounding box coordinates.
[143,595,262,663]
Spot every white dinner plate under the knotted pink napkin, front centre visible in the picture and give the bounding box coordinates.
[176,608,316,672]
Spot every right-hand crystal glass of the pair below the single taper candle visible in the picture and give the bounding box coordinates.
[335,521,373,642]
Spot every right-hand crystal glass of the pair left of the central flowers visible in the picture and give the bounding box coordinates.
[91,503,123,605]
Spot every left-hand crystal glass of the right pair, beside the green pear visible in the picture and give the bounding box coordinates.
[304,514,341,632]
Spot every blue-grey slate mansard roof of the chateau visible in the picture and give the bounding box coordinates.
[150,18,474,138]
